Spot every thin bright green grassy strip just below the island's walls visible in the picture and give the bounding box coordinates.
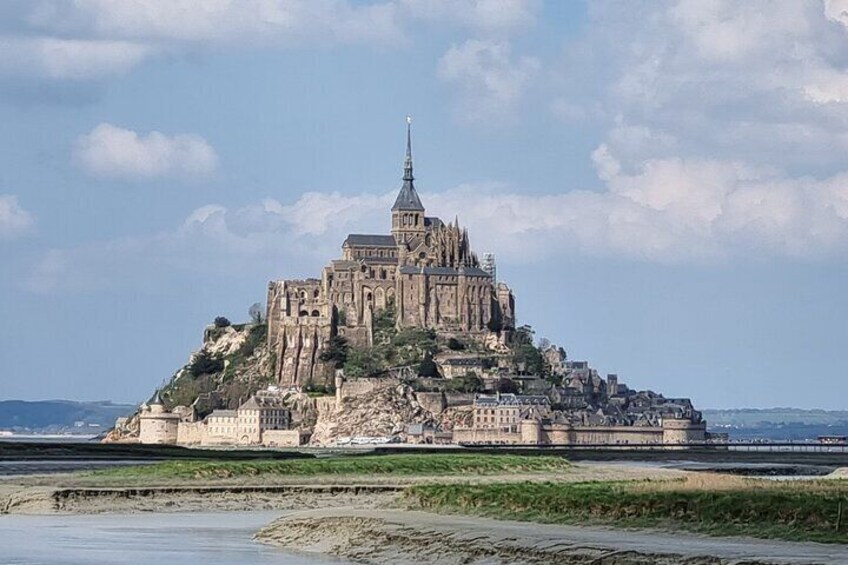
[91,453,569,480]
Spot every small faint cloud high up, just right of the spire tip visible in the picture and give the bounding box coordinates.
[438,39,540,122]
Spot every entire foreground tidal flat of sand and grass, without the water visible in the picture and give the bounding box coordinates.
[0,453,848,565]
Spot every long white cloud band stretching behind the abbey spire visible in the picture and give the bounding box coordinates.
[24,159,848,292]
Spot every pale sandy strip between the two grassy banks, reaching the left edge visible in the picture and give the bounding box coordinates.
[0,463,687,514]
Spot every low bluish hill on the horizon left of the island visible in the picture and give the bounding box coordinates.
[0,400,136,433]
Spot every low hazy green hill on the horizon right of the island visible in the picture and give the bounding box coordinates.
[701,408,848,441]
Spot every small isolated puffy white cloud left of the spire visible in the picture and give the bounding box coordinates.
[74,123,218,178]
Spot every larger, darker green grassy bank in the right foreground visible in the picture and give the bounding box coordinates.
[406,478,848,543]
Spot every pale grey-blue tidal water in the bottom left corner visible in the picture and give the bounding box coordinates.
[0,512,345,565]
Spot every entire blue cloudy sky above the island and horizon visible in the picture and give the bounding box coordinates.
[0,0,848,409]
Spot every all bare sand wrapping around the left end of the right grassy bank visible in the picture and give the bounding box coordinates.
[0,463,848,565]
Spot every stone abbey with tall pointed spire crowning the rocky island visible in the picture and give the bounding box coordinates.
[267,120,515,385]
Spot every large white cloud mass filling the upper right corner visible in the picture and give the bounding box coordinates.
[553,0,848,169]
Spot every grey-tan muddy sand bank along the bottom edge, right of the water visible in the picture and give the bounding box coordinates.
[256,508,848,565]
